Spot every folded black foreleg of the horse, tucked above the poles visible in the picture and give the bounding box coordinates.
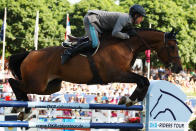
[115,72,150,106]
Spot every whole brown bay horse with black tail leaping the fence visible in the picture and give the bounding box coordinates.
[9,29,182,120]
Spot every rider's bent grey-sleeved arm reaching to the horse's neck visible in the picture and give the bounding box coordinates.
[112,15,130,39]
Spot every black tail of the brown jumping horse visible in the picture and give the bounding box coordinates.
[8,52,29,80]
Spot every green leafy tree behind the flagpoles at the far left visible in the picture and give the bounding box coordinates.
[0,0,70,54]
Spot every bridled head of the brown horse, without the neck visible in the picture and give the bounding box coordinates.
[157,29,182,73]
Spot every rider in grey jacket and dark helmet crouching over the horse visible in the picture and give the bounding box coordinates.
[61,4,146,64]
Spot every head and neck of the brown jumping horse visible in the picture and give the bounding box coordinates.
[126,28,182,73]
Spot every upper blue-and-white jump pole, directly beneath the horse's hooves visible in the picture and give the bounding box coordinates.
[0,101,143,111]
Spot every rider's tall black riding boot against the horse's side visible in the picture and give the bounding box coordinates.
[61,41,92,65]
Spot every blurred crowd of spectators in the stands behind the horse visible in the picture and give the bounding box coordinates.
[0,67,196,123]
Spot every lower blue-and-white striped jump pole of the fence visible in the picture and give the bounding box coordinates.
[0,121,144,129]
